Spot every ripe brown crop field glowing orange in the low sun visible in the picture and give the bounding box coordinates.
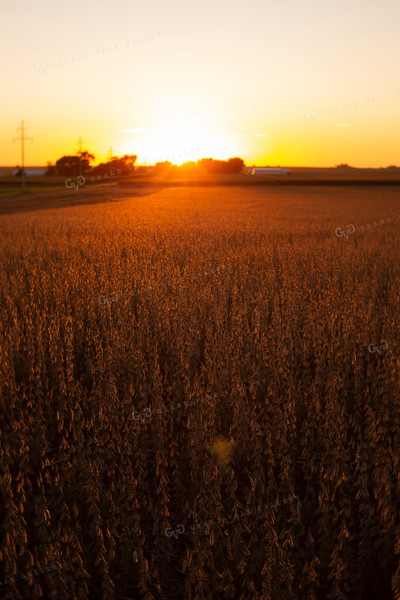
[0,185,400,600]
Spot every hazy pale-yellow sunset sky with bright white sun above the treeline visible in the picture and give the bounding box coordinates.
[0,0,400,167]
